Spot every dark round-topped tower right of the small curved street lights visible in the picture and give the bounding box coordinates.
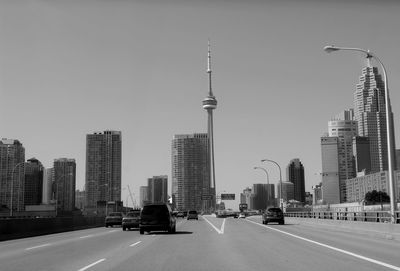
[286,158,306,203]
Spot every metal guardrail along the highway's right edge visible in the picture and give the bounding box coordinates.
[285,211,400,224]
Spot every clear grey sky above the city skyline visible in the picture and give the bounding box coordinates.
[0,0,400,208]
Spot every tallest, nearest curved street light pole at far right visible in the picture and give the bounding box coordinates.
[324,45,396,224]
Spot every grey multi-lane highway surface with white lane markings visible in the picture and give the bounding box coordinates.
[0,216,400,271]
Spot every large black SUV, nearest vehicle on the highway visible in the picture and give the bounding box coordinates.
[139,204,176,234]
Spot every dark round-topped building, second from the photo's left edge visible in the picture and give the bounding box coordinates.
[24,158,43,206]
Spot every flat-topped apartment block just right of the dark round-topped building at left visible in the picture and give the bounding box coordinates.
[54,158,76,214]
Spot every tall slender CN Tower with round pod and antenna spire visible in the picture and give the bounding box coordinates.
[203,41,217,192]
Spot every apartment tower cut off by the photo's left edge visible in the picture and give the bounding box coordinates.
[0,138,25,214]
